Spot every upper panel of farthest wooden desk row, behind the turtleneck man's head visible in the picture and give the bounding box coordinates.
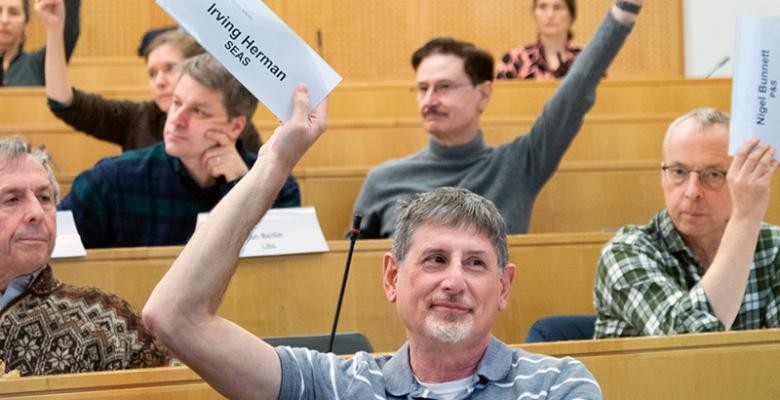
[0,77,731,125]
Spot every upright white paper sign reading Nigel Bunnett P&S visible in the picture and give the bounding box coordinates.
[729,15,780,157]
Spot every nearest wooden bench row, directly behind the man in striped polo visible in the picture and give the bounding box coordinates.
[0,329,780,400]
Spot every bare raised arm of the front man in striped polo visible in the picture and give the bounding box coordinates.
[143,86,326,398]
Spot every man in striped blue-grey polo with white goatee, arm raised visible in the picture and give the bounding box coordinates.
[143,88,601,400]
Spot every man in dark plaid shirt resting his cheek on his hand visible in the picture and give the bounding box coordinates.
[60,54,300,248]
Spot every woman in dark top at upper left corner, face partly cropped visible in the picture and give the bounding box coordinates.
[0,0,81,86]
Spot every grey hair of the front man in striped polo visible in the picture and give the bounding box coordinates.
[392,187,509,272]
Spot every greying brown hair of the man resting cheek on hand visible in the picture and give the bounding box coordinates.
[181,53,257,120]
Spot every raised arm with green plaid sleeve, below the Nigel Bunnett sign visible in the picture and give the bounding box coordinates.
[595,140,776,335]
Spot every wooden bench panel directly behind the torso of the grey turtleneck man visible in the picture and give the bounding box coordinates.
[54,160,780,240]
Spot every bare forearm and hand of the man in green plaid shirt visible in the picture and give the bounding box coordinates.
[701,139,777,330]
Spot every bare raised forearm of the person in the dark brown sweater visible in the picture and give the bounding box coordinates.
[44,23,73,106]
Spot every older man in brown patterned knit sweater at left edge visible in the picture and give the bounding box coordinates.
[0,137,168,376]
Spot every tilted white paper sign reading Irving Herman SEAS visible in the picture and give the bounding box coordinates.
[157,0,341,121]
